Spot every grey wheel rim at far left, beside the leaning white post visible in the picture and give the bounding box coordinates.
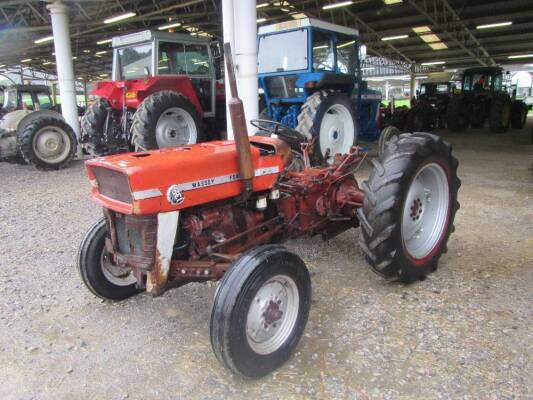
[32,126,72,164]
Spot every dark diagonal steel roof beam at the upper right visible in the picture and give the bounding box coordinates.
[406,0,496,66]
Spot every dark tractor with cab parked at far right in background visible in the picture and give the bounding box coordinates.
[446,67,528,133]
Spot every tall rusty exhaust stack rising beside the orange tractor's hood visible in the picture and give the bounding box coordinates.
[224,43,254,199]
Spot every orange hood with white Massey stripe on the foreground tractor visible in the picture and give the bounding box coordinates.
[85,137,291,215]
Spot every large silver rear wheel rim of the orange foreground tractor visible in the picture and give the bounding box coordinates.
[402,162,450,259]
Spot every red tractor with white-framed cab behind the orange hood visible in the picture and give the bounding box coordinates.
[81,31,226,155]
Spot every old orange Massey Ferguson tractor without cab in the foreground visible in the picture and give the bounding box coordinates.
[78,44,460,378]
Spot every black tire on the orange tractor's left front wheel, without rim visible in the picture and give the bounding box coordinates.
[78,218,139,300]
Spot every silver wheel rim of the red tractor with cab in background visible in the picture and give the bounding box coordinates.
[155,107,198,148]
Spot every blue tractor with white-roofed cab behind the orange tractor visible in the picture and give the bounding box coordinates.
[258,18,381,161]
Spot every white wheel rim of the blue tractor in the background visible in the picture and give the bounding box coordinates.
[320,104,355,161]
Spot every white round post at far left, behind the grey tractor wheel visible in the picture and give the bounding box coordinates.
[46,1,80,148]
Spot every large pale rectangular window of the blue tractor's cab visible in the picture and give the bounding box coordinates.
[257,29,307,74]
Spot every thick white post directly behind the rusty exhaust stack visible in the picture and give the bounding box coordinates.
[222,0,259,139]
